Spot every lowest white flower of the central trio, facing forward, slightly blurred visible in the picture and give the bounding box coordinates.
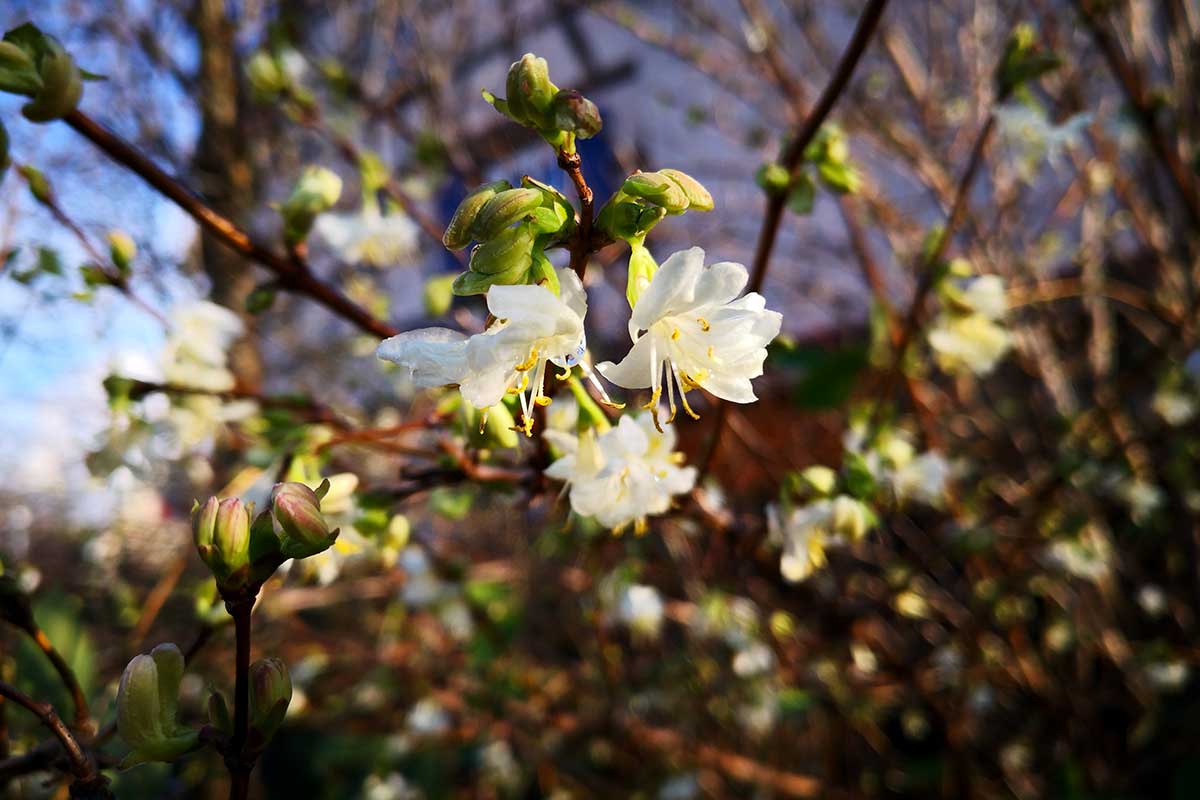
[546,414,696,534]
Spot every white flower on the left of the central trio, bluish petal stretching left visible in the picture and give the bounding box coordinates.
[377,269,588,435]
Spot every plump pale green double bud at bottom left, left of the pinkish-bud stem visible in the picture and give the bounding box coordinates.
[116,644,200,769]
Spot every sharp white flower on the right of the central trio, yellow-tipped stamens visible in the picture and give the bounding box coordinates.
[598,247,782,422]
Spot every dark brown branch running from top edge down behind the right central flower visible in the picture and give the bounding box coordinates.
[697,0,888,474]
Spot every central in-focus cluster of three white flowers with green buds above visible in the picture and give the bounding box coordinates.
[378,54,782,533]
